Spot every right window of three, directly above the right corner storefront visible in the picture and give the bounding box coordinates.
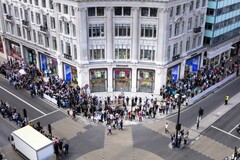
[140,46,155,61]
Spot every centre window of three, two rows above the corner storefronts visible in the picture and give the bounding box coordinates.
[115,24,130,37]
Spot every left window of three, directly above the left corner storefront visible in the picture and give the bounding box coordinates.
[90,45,105,60]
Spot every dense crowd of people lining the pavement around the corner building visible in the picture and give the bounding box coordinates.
[0,58,238,124]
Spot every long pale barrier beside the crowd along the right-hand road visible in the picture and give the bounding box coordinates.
[188,72,236,105]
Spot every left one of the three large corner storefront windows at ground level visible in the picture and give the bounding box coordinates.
[89,69,107,92]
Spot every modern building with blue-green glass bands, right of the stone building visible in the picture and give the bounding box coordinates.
[204,0,240,66]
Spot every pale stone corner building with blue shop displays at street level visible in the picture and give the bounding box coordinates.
[0,0,207,94]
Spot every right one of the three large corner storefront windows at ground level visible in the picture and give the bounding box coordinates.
[137,69,155,92]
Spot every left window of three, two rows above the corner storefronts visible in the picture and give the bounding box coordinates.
[88,24,104,37]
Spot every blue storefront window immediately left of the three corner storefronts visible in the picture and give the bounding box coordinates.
[64,64,78,84]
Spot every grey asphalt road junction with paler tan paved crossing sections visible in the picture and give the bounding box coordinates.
[0,75,240,160]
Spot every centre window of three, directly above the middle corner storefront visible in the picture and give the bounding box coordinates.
[115,45,130,60]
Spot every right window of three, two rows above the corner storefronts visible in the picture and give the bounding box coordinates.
[141,24,157,38]
